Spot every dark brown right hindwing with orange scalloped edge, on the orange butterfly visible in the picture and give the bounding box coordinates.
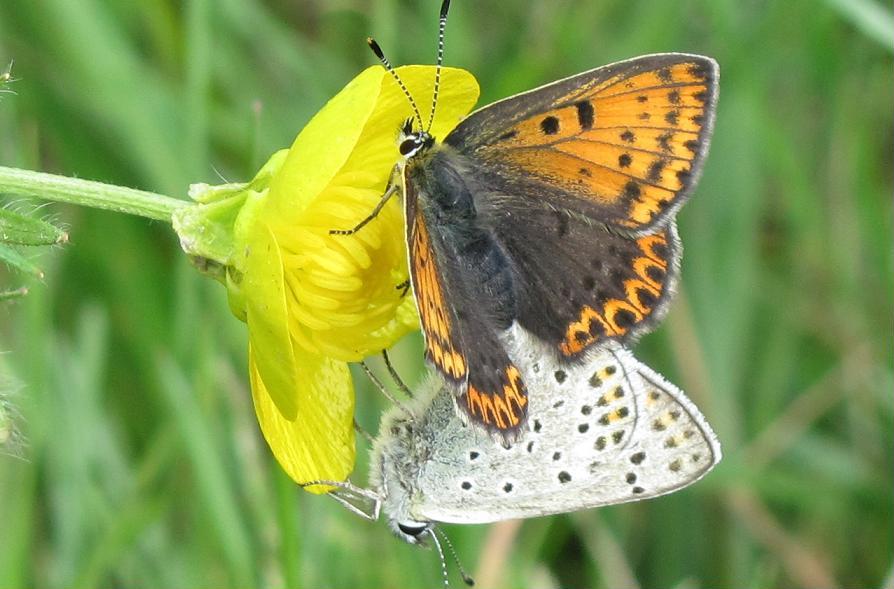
[490,203,680,358]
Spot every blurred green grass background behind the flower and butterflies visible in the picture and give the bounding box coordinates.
[0,0,894,588]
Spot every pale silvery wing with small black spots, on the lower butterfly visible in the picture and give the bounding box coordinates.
[414,346,720,523]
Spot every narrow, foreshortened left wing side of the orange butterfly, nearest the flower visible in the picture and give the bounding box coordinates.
[404,175,527,432]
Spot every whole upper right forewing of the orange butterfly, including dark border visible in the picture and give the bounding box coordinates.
[445,53,718,230]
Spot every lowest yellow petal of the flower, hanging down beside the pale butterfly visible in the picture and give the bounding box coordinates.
[248,347,355,493]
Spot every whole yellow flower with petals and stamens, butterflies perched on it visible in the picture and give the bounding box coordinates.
[175,66,478,492]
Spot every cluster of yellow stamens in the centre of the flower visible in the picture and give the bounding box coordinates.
[278,173,412,361]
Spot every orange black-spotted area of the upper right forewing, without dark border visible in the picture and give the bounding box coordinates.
[482,62,713,228]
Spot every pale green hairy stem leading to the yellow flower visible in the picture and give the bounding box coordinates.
[0,166,189,223]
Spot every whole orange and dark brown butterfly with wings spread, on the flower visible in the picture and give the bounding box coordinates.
[340,1,718,439]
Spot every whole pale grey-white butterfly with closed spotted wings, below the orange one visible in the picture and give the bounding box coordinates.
[334,345,721,543]
